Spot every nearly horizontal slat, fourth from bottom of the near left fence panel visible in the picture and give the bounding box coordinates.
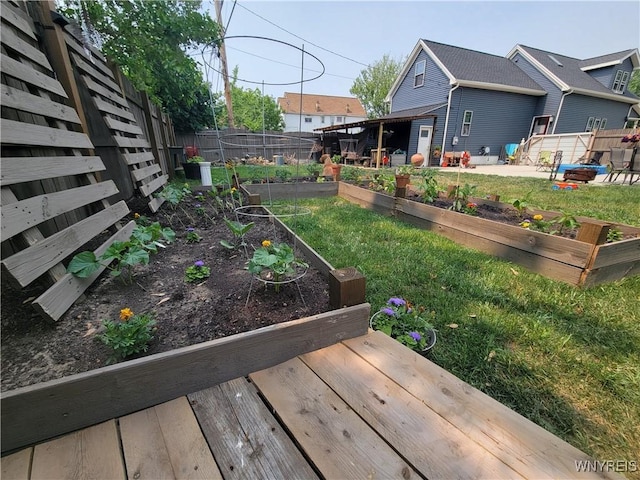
[0,156,105,187]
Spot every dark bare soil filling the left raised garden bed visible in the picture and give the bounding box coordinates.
[1,192,330,391]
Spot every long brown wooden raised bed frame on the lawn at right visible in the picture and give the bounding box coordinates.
[245,182,640,287]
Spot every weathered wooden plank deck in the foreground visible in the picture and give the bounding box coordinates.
[2,332,616,479]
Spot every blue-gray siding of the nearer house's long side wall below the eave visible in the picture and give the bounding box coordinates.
[438,88,538,155]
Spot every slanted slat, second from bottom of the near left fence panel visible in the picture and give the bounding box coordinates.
[2,200,129,287]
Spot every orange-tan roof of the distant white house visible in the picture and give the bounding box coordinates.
[278,92,367,117]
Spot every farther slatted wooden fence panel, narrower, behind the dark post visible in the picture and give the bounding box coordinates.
[65,30,168,212]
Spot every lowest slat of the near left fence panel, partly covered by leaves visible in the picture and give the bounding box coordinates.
[32,220,136,321]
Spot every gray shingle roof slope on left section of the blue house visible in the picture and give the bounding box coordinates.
[422,39,544,92]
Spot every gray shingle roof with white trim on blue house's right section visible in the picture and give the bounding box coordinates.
[507,45,639,103]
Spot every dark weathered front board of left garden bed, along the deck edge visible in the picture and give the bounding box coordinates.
[0,304,370,450]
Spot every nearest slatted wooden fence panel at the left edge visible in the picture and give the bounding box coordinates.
[0,2,135,320]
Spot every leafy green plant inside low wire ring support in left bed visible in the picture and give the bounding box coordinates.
[248,240,308,292]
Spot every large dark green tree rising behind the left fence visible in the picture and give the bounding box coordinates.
[61,0,220,131]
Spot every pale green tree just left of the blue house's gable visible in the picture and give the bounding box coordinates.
[349,55,404,118]
